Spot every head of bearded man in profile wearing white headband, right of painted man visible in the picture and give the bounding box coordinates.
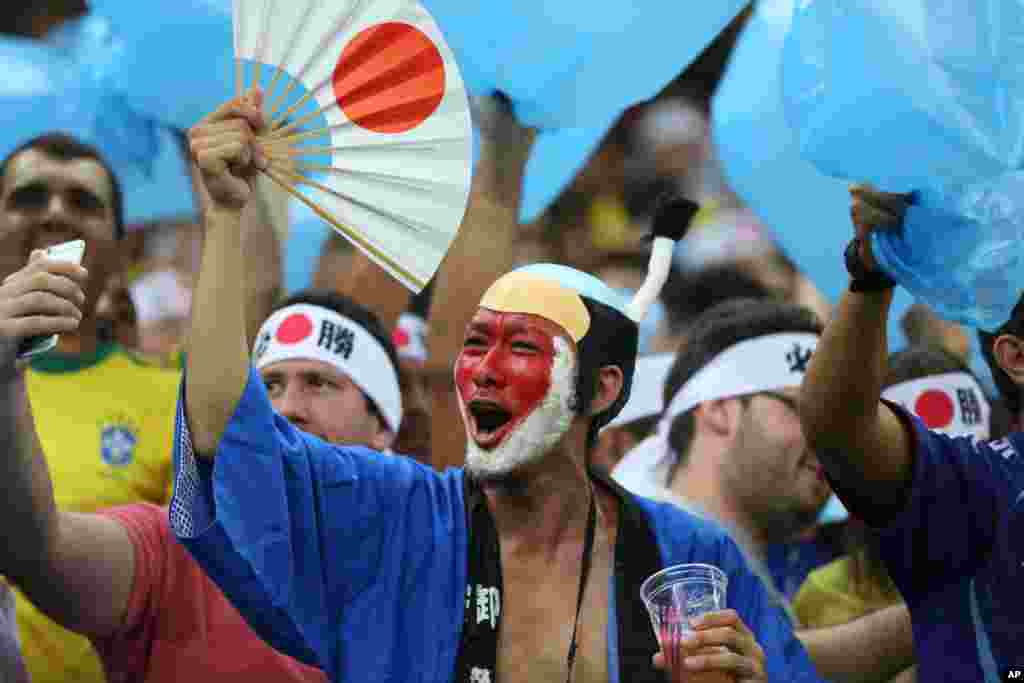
[613,299,830,561]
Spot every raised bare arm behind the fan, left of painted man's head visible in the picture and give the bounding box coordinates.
[427,97,534,469]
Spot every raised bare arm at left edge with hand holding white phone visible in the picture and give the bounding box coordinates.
[0,252,134,637]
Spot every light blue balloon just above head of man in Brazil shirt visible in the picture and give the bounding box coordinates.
[0,17,195,223]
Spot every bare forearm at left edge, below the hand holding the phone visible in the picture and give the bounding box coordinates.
[0,374,57,584]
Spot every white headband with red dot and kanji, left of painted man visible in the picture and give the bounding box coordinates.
[253,303,401,433]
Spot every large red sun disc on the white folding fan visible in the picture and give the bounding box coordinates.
[333,22,444,133]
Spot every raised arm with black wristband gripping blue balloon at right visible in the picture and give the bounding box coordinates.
[800,189,913,526]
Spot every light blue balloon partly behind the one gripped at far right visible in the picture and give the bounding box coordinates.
[712,0,912,350]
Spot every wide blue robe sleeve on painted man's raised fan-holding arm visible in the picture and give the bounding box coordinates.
[170,370,436,675]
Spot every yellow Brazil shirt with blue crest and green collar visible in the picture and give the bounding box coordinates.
[17,344,180,683]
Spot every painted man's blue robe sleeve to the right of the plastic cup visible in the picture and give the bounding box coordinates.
[718,537,822,683]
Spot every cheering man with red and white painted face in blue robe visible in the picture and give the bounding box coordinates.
[170,93,816,683]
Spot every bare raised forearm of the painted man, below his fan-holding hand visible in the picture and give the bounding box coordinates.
[185,209,249,457]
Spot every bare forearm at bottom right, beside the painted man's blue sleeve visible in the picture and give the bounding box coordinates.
[797,604,914,683]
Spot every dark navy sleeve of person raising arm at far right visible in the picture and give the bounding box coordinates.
[872,403,1012,605]
